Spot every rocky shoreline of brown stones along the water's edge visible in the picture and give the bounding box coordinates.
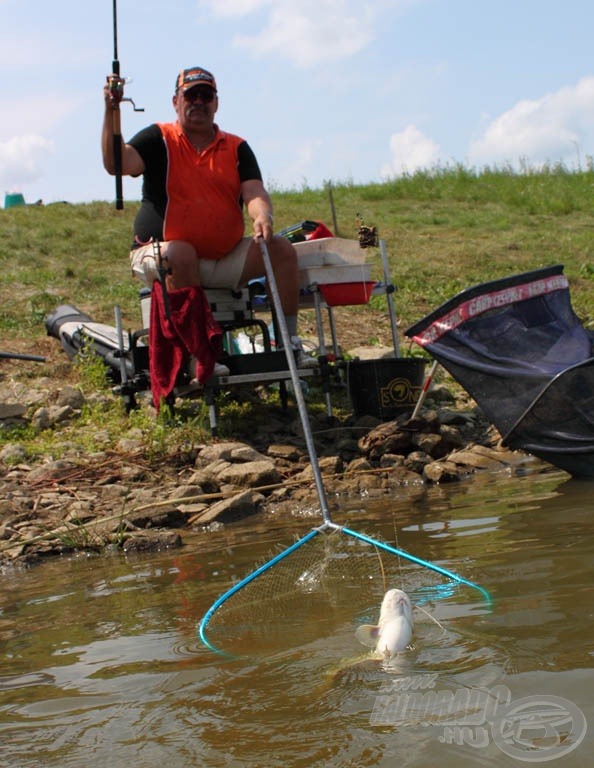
[0,378,518,569]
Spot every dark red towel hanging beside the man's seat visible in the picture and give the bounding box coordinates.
[149,281,223,409]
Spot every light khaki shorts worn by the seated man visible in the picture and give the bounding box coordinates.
[130,237,253,291]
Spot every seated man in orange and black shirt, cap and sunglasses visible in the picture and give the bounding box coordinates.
[101,67,316,380]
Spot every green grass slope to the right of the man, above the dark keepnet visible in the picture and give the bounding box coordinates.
[275,167,594,327]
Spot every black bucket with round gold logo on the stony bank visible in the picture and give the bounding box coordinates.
[347,357,426,421]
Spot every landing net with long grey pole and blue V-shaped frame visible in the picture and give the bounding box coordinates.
[198,238,491,657]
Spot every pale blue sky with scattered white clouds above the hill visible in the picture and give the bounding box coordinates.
[0,0,594,203]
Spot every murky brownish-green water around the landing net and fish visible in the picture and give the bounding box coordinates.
[0,460,594,768]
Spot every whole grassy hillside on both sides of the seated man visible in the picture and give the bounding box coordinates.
[0,167,594,460]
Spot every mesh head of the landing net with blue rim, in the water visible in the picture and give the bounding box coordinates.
[199,528,472,656]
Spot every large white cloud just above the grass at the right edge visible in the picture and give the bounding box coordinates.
[469,77,594,166]
